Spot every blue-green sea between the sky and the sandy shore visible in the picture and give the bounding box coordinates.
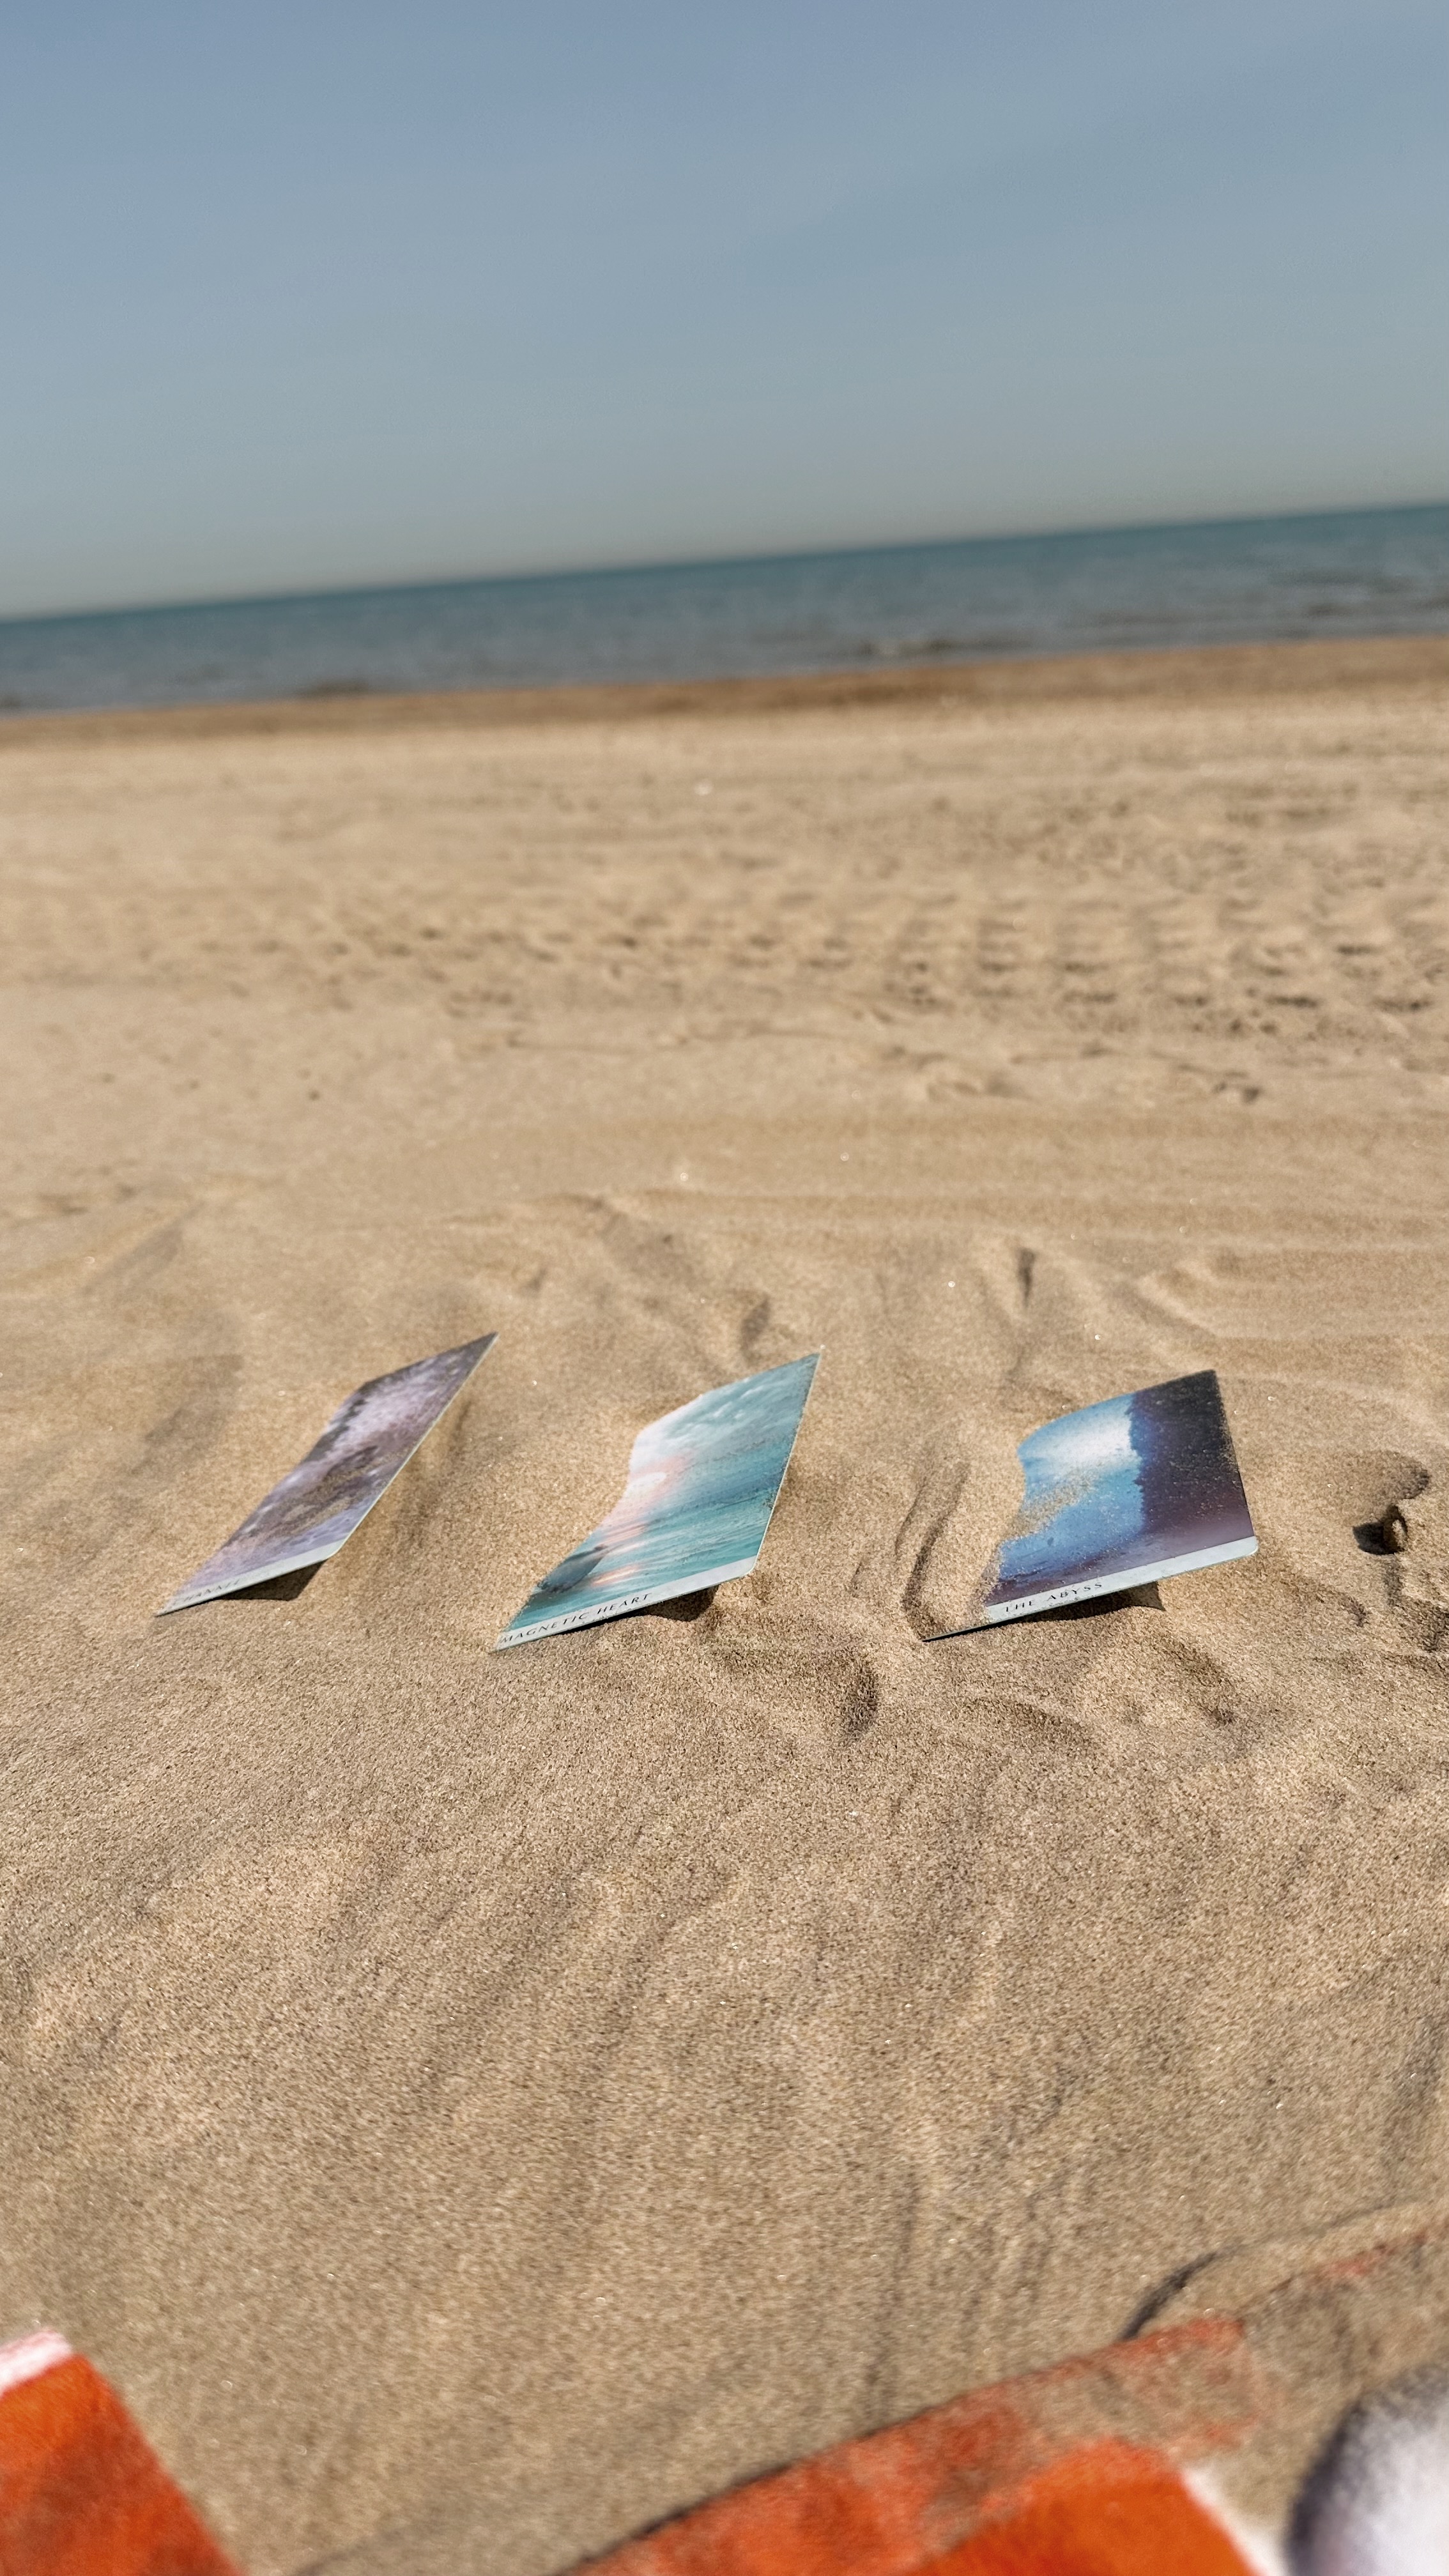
[0,505,1449,716]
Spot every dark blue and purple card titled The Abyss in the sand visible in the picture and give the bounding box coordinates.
[941,1368,1258,1636]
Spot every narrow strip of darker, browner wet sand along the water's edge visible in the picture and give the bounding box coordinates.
[0,634,1449,747]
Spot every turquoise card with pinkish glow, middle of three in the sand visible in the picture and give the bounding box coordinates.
[498,1350,820,1646]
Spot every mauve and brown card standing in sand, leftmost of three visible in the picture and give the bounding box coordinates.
[157,1332,498,1618]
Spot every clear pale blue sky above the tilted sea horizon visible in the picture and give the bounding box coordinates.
[0,0,1449,613]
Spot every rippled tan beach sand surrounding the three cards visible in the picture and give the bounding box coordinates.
[0,641,1449,2576]
